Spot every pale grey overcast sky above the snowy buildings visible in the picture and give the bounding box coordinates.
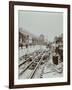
[18,10,63,41]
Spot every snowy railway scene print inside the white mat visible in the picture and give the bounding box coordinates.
[18,10,63,79]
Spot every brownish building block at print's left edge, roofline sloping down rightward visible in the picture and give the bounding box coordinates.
[19,28,38,46]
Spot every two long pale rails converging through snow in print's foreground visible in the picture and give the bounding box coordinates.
[19,52,49,78]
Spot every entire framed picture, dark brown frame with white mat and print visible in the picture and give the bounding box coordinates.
[9,1,70,88]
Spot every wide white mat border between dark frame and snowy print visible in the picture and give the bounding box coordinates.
[14,5,67,85]
